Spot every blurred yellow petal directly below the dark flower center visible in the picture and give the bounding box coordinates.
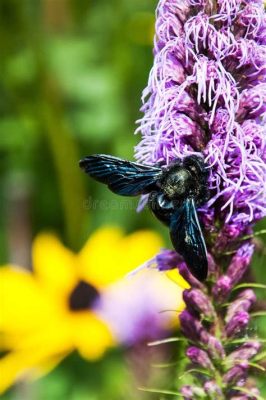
[69,311,114,360]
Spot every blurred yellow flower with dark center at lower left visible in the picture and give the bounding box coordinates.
[0,227,166,392]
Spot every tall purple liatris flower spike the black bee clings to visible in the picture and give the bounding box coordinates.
[136,0,266,400]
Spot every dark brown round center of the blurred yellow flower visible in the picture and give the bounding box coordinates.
[68,281,99,311]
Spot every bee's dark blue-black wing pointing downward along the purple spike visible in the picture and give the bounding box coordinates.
[170,198,208,281]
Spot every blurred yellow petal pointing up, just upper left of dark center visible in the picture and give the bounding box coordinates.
[33,233,78,293]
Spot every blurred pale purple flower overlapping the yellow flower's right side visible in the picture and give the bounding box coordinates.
[97,270,183,346]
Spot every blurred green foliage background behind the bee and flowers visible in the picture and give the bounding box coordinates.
[0,0,266,400]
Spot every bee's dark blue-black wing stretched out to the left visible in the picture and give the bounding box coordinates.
[79,154,162,196]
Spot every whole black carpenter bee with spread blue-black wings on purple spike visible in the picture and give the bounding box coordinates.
[79,154,208,281]
